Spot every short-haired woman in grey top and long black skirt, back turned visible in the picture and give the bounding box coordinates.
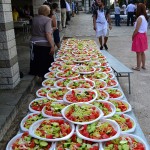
[29,5,54,80]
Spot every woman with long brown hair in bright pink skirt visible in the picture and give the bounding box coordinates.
[132,3,148,71]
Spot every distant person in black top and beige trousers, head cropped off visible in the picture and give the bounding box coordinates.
[60,0,66,28]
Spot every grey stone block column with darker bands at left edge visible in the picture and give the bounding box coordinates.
[0,0,20,89]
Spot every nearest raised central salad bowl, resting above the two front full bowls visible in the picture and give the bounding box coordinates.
[62,103,104,125]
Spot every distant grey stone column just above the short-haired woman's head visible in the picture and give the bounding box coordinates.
[32,0,45,15]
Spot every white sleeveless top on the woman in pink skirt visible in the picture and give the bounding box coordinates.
[134,15,148,33]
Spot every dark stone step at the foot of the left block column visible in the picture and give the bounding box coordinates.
[0,76,34,141]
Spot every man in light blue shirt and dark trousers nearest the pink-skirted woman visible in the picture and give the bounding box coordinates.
[126,1,136,26]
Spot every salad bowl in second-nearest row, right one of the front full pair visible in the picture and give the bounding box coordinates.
[76,119,120,142]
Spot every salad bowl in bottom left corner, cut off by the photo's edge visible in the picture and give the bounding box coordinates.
[6,132,54,150]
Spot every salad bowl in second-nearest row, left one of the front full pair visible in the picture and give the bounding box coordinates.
[29,118,75,142]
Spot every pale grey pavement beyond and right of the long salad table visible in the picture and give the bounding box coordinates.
[64,13,150,143]
